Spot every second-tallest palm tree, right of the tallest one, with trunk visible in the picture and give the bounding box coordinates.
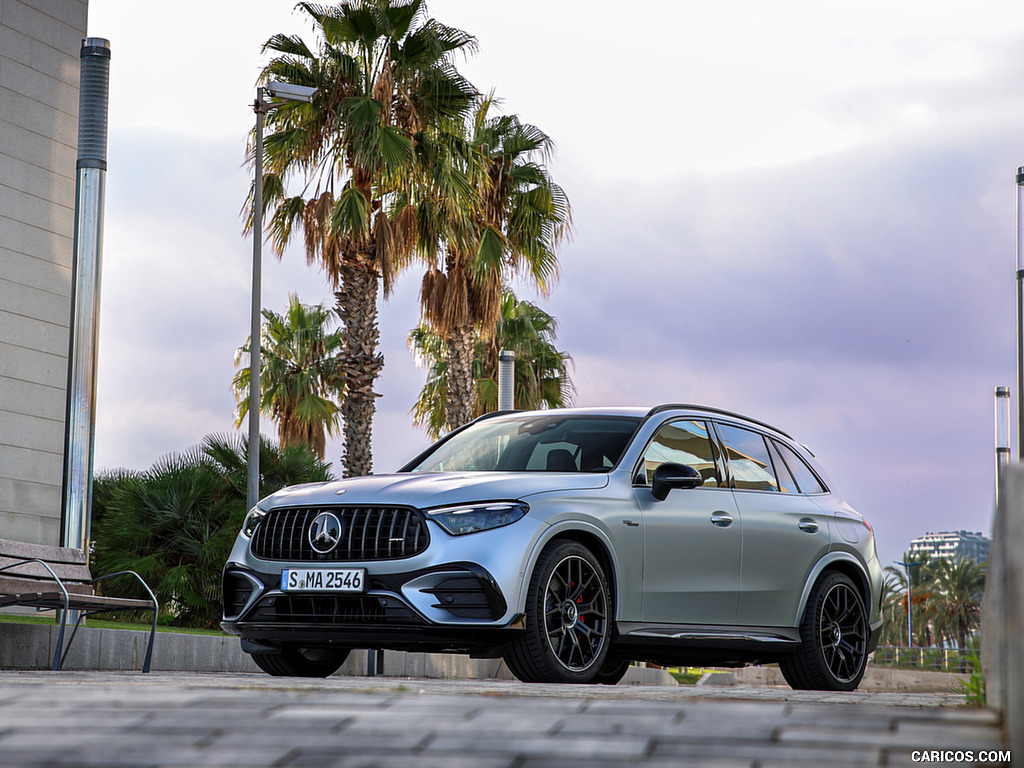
[420,95,571,429]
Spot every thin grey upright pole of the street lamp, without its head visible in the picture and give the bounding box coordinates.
[246,88,267,509]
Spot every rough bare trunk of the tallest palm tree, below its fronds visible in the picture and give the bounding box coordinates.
[335,260,384,477]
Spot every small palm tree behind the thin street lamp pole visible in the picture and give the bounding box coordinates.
[231,294,344,459]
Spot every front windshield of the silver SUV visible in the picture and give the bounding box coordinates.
[407,414,640,472]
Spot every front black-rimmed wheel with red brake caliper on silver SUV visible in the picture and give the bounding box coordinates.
[505,541,606,683]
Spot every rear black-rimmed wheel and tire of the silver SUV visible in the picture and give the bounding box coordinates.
[778,570,868,691]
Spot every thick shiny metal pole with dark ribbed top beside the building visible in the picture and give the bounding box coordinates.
[60,38,111,552]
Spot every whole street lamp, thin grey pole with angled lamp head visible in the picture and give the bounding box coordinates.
[246,82,316,509]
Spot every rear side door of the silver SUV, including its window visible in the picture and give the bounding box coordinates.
[715,423,830,627]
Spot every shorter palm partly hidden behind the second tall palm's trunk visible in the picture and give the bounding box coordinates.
[409,291,575,439]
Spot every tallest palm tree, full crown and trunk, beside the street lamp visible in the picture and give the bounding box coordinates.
[248,0,476,476]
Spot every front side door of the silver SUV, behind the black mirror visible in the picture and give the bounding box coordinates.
[634,419,742,625]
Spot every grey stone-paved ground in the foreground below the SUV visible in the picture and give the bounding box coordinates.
[0,671,1012,768]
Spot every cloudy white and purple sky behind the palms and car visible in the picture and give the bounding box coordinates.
[89,0,1024,562]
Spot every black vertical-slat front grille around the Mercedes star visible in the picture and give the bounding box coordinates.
[250,507,430,562]
